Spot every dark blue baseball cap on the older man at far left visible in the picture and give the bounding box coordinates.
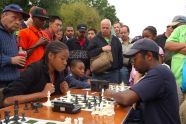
[3,4,30,18]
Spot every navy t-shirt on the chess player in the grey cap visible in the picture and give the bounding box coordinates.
[131,65,180,124]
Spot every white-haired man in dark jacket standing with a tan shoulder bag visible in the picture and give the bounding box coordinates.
[88,19,123,83]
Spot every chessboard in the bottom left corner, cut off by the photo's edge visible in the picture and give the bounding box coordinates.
[1,116,62,124]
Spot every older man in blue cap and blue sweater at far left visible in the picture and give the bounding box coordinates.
[0,4,29,88]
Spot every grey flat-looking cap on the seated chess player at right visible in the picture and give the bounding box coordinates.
[124,38,159,57]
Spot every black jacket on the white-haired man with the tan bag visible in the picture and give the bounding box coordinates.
[88,32,123,71]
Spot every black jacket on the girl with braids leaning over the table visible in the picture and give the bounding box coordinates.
[3,60,64,98]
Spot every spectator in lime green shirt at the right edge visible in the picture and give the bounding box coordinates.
[165,16,186,86]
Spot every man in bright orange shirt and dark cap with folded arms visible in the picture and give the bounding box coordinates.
[19,7,48,67]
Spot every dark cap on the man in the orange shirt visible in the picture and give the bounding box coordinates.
[31,7,48,19]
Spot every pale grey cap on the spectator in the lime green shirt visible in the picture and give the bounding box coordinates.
[169,15,186,26]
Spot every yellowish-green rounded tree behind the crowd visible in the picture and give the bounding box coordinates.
[59,2,101,29]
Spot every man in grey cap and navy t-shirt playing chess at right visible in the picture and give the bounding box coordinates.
[104,39,180,124]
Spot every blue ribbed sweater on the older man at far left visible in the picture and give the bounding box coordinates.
[0,25,20,81]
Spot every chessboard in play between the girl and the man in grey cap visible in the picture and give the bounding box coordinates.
[51,94,115,111]
